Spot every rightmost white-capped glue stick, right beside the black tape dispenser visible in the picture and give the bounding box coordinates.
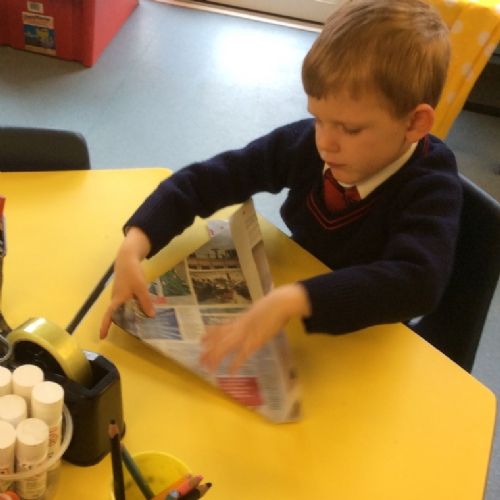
[31,381,64,470]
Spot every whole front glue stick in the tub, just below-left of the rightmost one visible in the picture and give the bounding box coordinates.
[16,418,49,500]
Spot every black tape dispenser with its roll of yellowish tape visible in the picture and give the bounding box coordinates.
[0,317,125,465]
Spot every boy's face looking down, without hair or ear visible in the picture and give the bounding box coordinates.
[308,92,411,184]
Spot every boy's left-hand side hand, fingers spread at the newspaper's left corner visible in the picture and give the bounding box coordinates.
[99,227,155,339]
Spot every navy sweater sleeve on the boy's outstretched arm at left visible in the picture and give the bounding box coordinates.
[125,120,313,257]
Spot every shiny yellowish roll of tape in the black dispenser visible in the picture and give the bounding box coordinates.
[7,317,92,387]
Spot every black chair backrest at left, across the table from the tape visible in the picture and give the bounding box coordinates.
[0,127,90,172]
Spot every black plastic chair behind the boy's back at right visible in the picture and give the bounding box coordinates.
[411,176,500,372]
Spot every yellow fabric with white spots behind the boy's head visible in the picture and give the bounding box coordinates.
[428,0,500,138]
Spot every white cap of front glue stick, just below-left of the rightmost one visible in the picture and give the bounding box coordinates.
[16,418,49,463]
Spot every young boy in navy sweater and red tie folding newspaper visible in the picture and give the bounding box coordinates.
[101,0,461,371]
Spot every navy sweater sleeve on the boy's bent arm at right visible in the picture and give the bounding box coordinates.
[302,166,462,334]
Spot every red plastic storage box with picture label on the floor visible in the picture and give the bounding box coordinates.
[0,0,139,66]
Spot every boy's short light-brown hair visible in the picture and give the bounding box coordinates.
[302,0,450,117]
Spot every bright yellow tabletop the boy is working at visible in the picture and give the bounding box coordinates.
[0,168,496,500]
